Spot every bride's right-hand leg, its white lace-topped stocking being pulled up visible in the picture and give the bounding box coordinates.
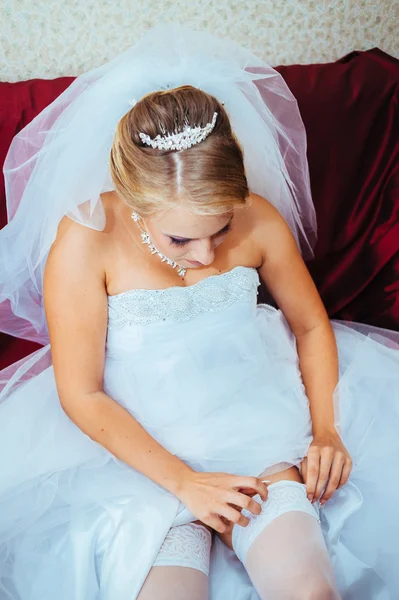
[220,467,340,600]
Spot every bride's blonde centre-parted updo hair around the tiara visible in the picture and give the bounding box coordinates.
[110,85,249,218]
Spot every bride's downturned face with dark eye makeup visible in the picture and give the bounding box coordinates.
[143,206,234,269]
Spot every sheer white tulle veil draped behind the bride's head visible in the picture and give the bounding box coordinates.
[0,23,316,344]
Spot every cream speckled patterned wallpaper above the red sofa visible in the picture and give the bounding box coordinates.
[0,0,399,81]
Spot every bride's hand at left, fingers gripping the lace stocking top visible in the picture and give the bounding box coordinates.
[176,471,267,533]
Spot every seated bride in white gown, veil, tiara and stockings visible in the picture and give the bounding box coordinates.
[0,24,399,600]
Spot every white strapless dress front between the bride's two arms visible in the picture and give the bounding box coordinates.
[104,266,309,474]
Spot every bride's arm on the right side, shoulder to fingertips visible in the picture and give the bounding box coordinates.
[253,195,352,504]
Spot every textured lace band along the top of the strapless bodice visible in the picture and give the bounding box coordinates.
[108,266,260,329]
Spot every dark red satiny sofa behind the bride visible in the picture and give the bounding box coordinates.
[0,48,399,369]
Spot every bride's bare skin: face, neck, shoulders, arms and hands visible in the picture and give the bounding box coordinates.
[44,192,351,547]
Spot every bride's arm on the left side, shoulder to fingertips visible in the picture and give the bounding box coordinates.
[43,217,266,532]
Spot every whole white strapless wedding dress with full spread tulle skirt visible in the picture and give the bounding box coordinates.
[0,266,399,600]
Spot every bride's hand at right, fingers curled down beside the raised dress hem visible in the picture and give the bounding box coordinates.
[301,429,352,506]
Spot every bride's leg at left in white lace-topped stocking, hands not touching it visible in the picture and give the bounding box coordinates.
[138,522,212,600]
